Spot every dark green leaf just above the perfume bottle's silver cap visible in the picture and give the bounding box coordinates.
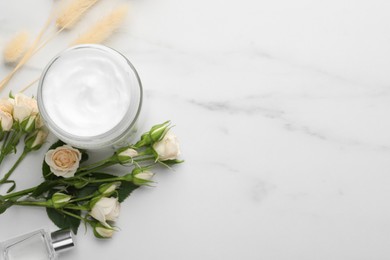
[46,208,81,234]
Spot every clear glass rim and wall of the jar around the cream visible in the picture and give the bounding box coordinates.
[37,44,143,149]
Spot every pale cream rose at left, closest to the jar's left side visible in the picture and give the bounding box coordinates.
[13,93,38,122]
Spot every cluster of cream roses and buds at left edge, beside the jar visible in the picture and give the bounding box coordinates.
[0,93,48,190]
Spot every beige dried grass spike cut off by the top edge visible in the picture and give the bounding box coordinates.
[56,0,98,29]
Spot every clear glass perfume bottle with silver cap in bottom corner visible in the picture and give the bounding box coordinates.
[0,229,74,260]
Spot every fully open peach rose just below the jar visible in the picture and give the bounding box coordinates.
[45,145,81,178]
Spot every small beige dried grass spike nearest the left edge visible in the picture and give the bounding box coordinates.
[3,31,29,63]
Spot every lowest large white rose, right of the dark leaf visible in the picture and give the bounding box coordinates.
[89,197,120,227]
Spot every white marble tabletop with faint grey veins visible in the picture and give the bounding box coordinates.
[0,0,390,260]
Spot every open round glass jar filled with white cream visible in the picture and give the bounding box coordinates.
[37,44,142,149]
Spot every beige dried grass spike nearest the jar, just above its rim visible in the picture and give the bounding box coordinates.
[72,5,129,45]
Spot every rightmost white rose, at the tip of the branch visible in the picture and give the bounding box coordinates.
[153,131,180,161]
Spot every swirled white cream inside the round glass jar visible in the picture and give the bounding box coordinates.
[42,48,131,137]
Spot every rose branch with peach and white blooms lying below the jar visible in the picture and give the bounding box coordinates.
[0,122,182,238]
